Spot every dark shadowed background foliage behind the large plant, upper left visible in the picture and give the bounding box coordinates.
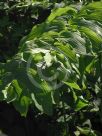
[0,0,50,58]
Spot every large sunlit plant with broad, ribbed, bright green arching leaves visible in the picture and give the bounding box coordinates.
[0,2,102,136]
